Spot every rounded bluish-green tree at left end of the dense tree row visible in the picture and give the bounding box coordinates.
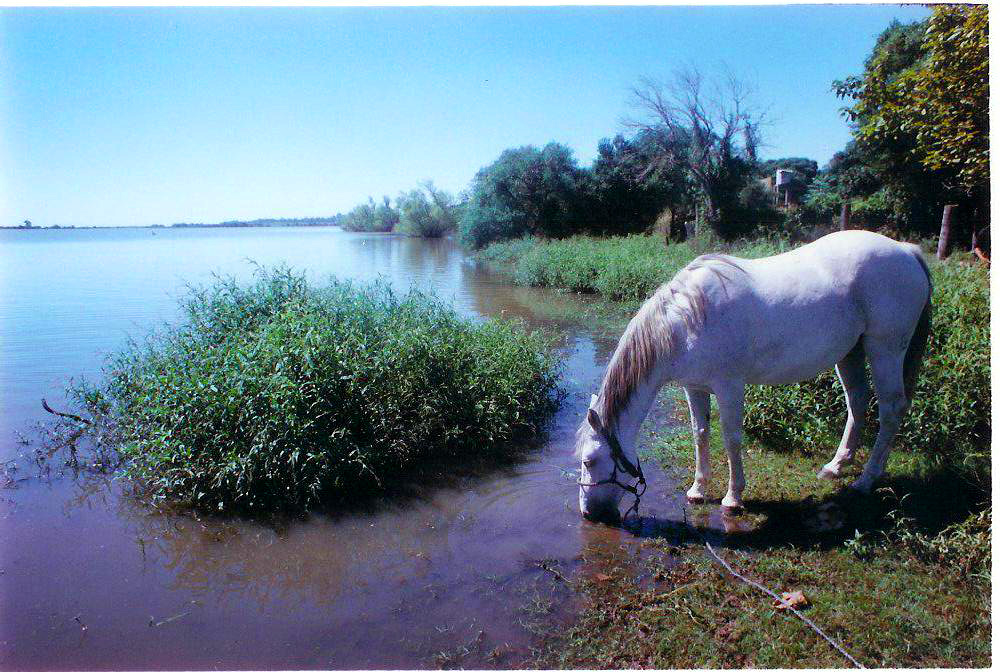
[460,142,584,248]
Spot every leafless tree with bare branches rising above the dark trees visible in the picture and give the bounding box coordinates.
[627,69,766,237]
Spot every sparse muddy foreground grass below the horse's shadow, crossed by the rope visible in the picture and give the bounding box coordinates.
[534,542,990,669]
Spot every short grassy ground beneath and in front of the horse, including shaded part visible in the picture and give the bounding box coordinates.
[533,390,992,668]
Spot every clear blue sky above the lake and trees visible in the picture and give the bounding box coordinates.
[0,5,928,226]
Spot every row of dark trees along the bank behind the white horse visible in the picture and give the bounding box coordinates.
[458,5,989,255]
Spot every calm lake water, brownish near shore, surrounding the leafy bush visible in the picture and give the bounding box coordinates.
[0,229,681,669]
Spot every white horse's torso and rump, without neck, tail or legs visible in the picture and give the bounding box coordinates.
[676,231,928,384]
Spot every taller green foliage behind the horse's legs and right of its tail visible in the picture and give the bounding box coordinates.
[744,262,992,487]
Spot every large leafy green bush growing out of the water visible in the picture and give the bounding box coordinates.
[75,270,556,512]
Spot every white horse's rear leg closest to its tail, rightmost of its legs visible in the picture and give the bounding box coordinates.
[851,339,910,492]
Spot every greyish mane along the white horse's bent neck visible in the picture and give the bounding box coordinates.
[597,254,745,426]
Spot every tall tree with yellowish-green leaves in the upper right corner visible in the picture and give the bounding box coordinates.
[834,5,989,239]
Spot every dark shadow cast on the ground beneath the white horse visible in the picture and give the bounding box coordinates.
[625,469,989,551]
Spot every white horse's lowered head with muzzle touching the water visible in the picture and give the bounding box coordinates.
[576,396,628,524]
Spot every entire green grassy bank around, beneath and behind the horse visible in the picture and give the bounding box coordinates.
[478,236,992,668]
